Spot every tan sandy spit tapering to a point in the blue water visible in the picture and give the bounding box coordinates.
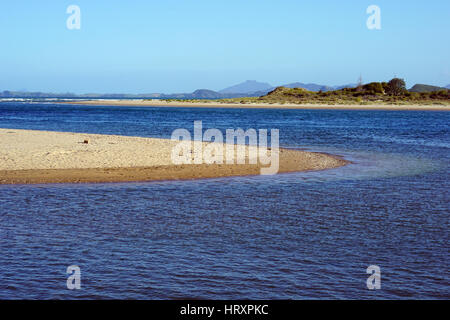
[0,129,347,184]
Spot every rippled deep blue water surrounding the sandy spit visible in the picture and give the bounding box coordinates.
[0,102,450,299]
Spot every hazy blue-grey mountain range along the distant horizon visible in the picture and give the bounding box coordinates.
[0,80,450,99]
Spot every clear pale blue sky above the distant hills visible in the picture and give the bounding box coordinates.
[0,0,450,93]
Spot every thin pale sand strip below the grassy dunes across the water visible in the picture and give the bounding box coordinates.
[55,99,450,111]
